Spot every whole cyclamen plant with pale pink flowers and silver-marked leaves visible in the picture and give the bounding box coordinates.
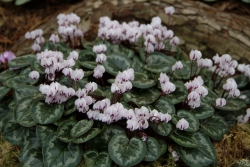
[0,7,250,167]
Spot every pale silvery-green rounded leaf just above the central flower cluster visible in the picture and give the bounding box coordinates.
[103,53,132,76]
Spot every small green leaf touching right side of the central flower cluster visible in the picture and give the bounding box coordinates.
[132,72,156,89]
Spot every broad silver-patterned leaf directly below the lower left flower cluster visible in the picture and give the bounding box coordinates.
[31,101,64,124]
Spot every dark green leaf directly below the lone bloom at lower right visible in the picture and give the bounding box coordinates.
[170,130,199,148]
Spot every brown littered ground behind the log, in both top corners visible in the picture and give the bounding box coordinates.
[0,0,250,53]
